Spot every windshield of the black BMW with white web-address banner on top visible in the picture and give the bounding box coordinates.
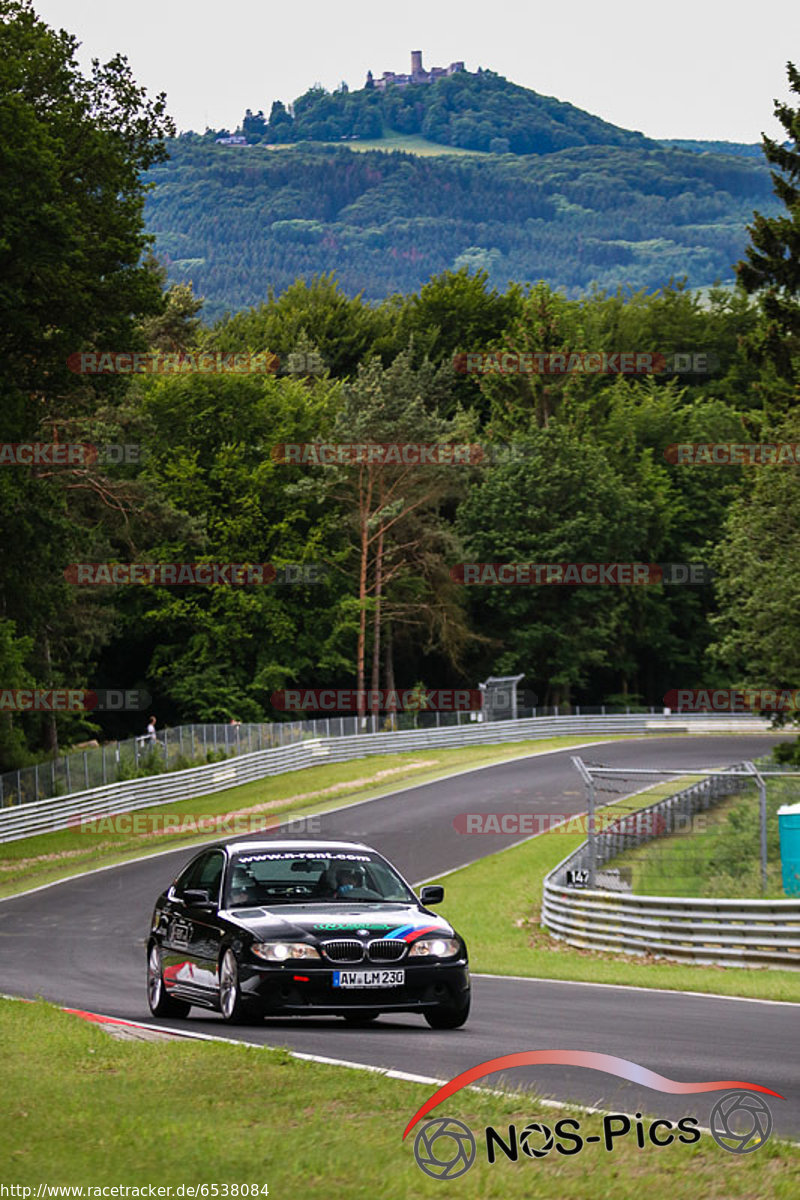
[225,850,416,908]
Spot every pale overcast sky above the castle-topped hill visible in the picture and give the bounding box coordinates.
[34,0,800,142]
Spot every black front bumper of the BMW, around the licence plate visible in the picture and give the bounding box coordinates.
[239,959,470,1015]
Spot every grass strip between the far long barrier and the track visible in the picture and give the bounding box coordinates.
[0,736,624,896]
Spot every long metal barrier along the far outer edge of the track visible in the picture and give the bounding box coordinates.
[0,713,770,842]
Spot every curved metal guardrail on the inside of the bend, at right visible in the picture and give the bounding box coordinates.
[541,768,800,970]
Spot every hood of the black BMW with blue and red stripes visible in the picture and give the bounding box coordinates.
[225,902,453,942]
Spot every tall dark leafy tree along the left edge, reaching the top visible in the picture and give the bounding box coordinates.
[0,0,174,763]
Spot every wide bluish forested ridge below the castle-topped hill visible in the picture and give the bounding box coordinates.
[146,134,775,319]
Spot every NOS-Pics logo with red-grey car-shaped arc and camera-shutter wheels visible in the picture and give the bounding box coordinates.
[403,1050,784,1180]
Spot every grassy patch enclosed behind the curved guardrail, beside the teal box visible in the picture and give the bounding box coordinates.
[599,779,800,900]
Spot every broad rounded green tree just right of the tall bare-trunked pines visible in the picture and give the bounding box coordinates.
[456,424,649,704]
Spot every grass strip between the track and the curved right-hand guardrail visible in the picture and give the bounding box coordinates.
[431,780,800,1003]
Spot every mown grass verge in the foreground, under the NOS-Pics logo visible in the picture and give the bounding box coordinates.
[0,1001,800,1200]
